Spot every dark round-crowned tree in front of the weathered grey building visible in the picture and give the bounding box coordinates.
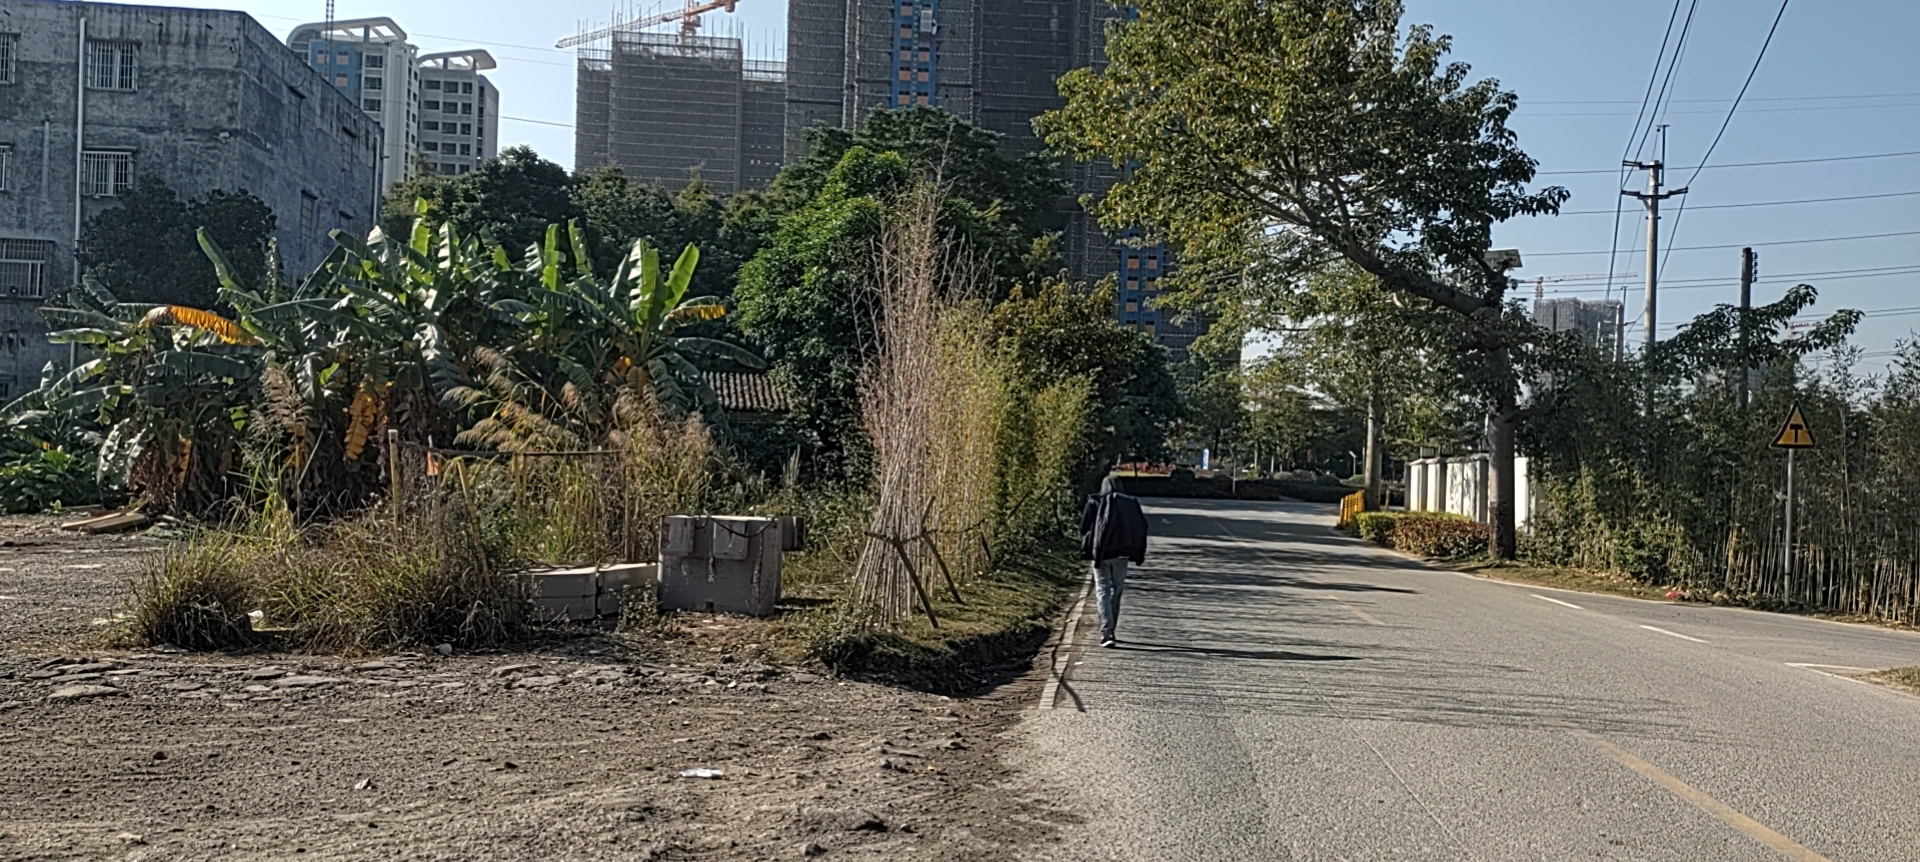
[77,177,276,309]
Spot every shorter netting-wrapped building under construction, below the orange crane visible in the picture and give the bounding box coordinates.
[574,33,785,194]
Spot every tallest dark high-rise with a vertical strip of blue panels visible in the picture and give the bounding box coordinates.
[785,0,1206,359]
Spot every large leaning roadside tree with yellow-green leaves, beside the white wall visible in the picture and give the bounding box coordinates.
[1043,0,1567,559]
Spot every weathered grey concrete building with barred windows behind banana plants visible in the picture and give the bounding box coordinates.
[0,0,380,399]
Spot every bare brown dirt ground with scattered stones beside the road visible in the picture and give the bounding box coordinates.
[0,518,1077,860]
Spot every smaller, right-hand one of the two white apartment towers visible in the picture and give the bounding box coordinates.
[419,50,499,175]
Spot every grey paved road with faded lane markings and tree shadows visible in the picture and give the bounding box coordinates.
[1027,501,1920,862]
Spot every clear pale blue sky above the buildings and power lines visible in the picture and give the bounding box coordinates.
[116,0,1920,367]
